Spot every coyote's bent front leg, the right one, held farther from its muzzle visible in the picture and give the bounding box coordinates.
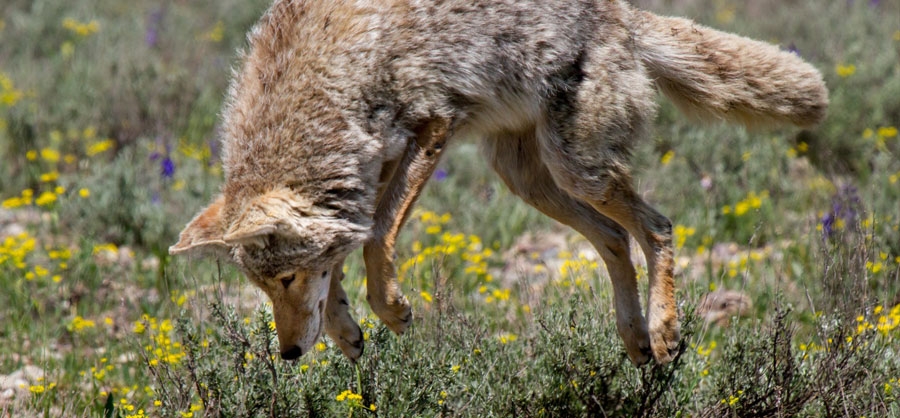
[363,119,450,334]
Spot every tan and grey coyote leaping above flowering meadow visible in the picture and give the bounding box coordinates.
[169,0,828,365]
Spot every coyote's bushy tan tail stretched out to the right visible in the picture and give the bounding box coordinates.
[634,10,828,127]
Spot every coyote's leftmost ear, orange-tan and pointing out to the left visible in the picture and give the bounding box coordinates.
[169,195,229,255]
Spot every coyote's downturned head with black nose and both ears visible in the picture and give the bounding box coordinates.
[169,189,368,360]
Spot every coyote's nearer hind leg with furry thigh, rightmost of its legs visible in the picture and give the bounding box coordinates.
[538,39,680,363]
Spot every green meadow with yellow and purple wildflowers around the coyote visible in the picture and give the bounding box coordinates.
[0,0,900,418]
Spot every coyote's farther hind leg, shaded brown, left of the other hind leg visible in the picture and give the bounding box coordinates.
[484,134,650,365]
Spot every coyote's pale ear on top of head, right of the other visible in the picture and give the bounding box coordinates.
[222,190,300,247]
